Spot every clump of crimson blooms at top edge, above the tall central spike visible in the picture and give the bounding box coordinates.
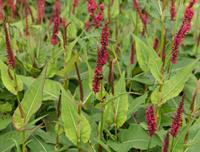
[85,0,104,29]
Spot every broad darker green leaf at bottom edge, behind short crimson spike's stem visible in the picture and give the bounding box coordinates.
[108,124,162,152]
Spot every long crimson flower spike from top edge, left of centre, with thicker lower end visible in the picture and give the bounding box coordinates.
[51,0,61,45]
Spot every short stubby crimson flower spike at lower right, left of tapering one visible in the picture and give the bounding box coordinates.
[146,105,157,137]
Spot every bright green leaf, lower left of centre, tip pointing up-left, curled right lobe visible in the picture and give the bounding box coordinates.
[61,88,91,145]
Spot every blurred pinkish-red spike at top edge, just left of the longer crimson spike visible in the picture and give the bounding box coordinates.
[37,0,45,24]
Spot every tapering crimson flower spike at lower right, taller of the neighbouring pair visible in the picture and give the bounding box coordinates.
[170,94,184,137]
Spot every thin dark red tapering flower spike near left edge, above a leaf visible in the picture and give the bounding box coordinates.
[4,23,16,68]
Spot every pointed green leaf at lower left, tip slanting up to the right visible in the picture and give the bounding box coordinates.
[13,67,47,130]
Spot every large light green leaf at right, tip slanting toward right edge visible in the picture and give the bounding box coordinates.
[151,61,197,105]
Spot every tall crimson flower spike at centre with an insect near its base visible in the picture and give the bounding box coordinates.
[93,23,110,93]
